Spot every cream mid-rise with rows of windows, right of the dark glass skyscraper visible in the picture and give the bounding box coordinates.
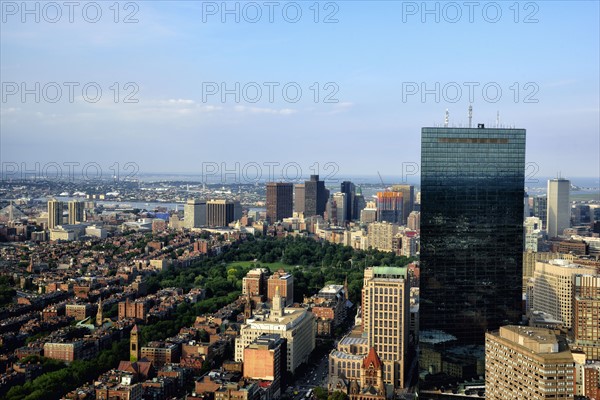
[533,260,596,328]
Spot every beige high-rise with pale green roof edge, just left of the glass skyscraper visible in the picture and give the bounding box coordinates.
[362,267,410,389]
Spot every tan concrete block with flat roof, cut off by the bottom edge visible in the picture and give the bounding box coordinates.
[485,325,575,400]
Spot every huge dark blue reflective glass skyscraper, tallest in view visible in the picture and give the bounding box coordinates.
[419,124,525,374]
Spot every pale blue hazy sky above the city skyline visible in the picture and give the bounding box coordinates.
[0,1,600,181]
